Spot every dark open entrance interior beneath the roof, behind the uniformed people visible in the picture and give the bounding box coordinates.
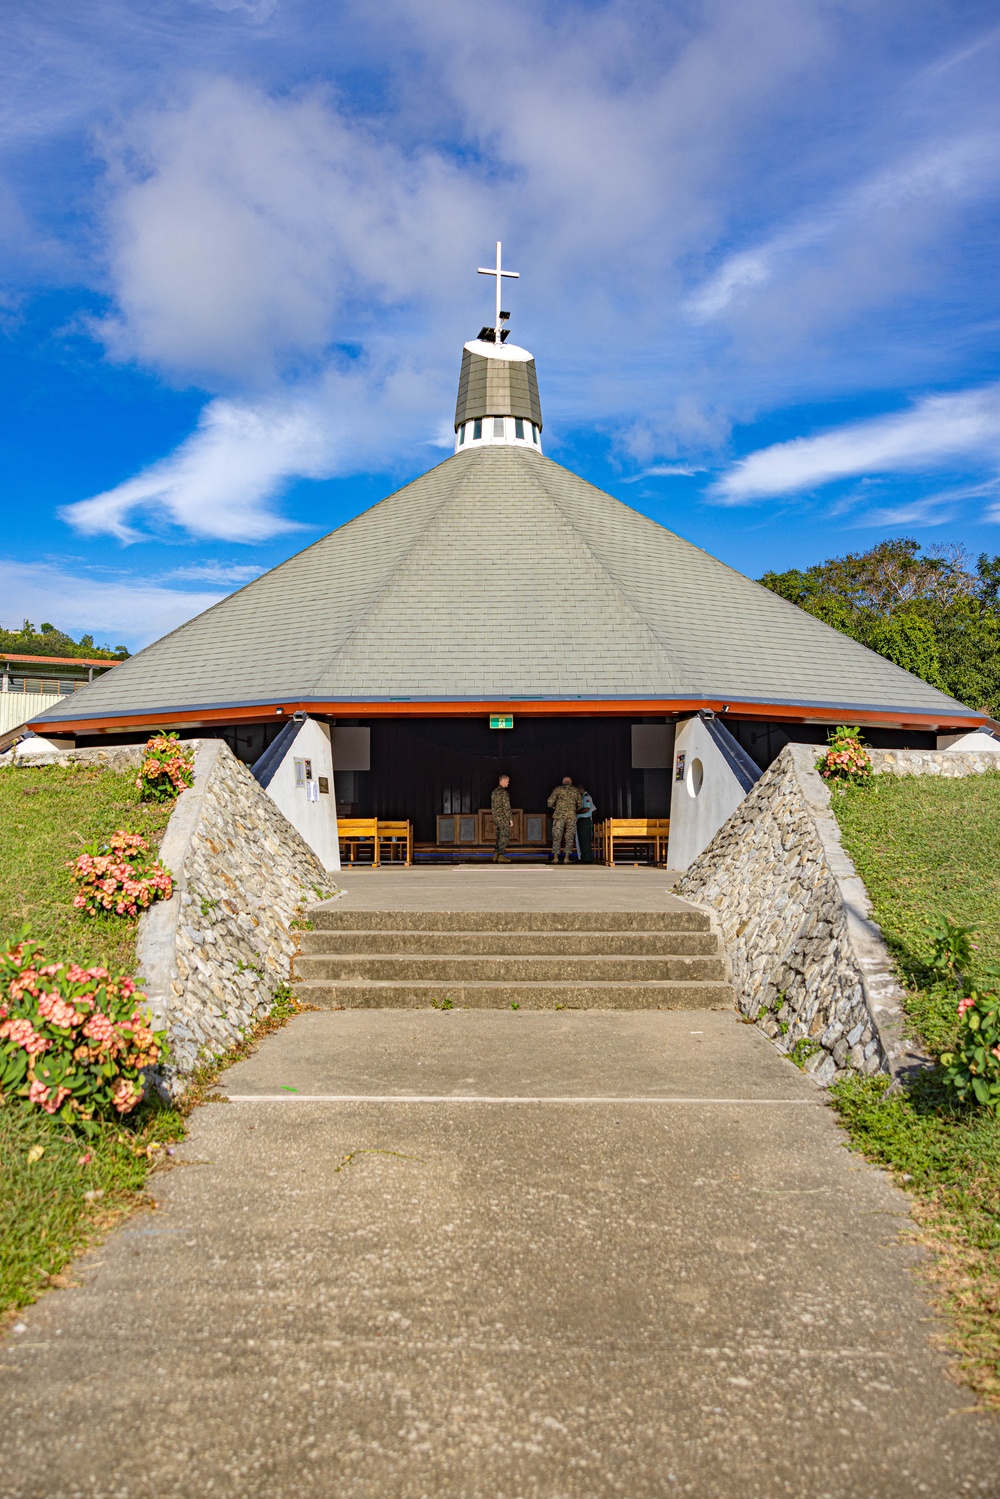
[334,715,670,860]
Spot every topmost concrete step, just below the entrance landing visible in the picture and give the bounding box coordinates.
[307,902,711,932]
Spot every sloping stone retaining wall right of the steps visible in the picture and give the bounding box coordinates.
[676,745,999,1084]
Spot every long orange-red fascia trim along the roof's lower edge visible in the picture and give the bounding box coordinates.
[28,697,1000,735]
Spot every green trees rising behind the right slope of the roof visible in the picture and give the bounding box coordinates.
[759,537,1000,718]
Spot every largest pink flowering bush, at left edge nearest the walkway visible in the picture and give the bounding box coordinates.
[0,940,166,1124]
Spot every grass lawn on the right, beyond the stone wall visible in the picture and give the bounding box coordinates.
[832,772,1000,1406]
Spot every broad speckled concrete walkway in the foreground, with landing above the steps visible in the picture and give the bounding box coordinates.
[0,871,1000,1499]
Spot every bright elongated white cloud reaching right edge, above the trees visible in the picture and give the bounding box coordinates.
[709,384,1000,504]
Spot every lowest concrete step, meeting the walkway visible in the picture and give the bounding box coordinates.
[295,979,735,1010]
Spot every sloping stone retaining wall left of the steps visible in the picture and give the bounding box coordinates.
[138,739,330,1093]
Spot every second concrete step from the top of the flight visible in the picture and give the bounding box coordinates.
[300,929,718,958]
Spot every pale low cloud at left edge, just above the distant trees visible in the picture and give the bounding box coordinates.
[0,559,223,649]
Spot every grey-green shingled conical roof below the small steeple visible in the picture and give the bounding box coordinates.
[36,445,982,729]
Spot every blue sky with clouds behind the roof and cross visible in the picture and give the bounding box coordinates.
[0,0,1000,648]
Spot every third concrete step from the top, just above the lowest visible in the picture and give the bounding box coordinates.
[295,953,726,983]
